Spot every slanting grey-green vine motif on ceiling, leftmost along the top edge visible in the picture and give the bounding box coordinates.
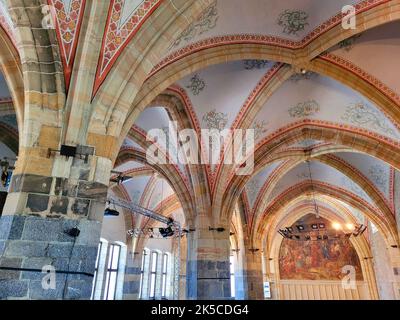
[170,1,219,49]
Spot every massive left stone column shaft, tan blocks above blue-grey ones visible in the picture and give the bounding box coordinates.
[0,148,112,299]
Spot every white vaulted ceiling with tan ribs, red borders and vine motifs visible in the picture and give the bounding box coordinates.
[0,0,400,244]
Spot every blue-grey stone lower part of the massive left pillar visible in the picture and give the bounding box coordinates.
[0,215,101,300]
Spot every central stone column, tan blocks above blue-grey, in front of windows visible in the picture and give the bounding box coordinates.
[186,216,231,300]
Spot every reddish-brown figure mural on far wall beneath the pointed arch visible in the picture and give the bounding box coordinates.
[279,214,363,281]
